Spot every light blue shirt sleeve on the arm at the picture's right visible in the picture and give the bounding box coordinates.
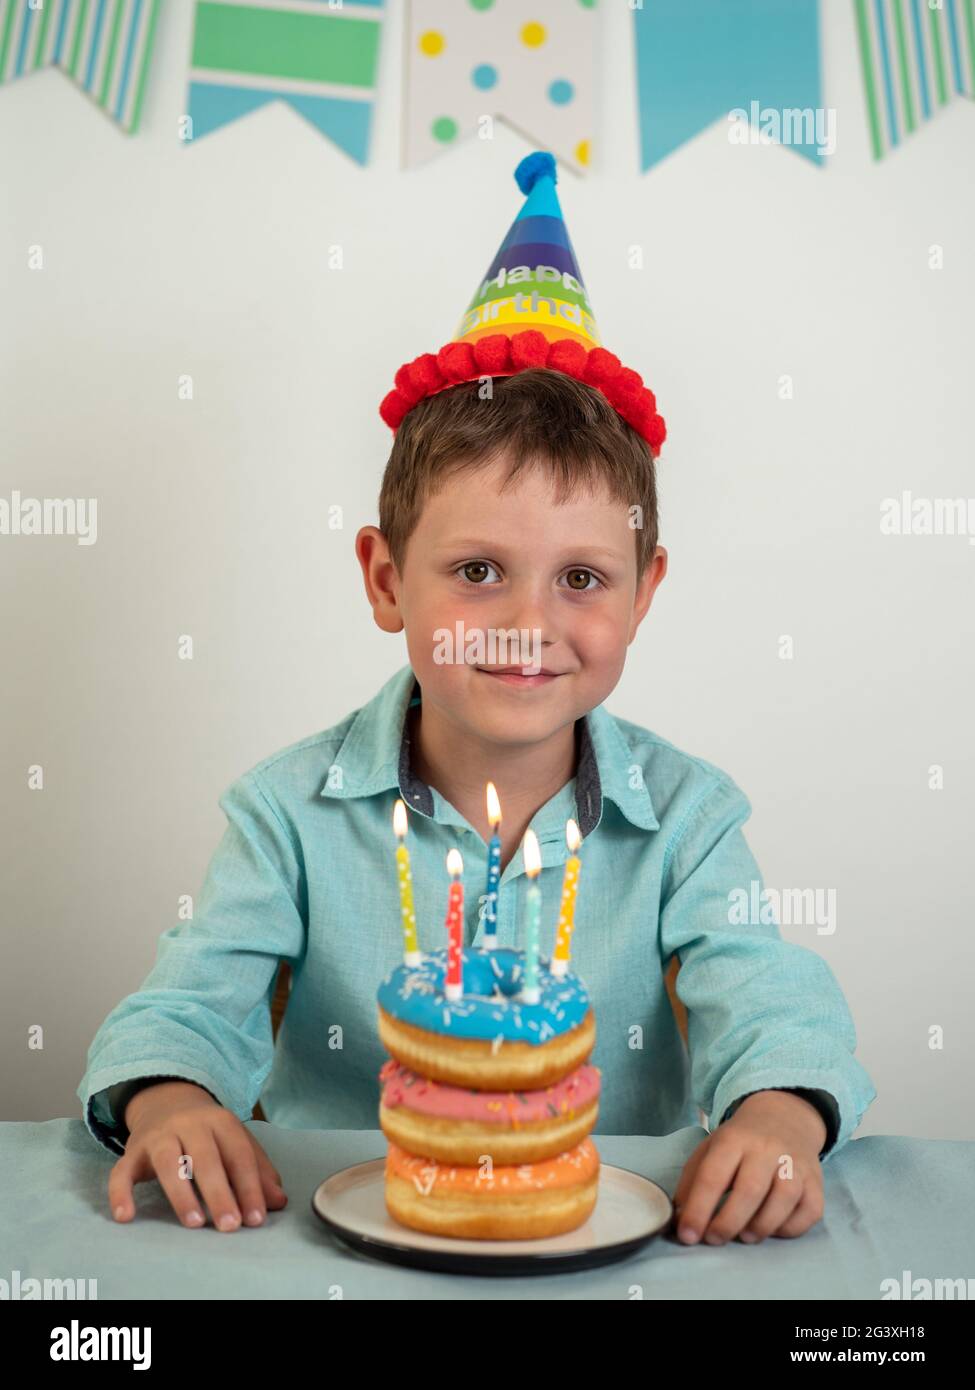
[659,777,876,1159]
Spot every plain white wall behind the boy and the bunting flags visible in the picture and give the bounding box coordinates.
[0,0,975,1138]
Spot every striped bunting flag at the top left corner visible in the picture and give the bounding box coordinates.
[0,0,160,135]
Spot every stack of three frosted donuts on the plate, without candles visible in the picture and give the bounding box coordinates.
[378,947,599,1240]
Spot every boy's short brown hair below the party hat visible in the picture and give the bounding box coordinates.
[380,367,658,581]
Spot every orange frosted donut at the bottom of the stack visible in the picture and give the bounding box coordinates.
[385,1138,599,1240]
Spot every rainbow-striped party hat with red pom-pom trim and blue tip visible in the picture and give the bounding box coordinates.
[380,150,666,457]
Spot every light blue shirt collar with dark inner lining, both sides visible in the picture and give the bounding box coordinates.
[320,664,659,837]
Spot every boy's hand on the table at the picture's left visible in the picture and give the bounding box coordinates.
[108,1081,288,1230]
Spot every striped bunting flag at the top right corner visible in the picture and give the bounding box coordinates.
[854,0,975,160]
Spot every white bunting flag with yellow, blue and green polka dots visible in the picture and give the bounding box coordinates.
[403,0,595,174]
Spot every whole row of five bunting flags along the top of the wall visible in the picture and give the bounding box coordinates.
[0,0,975,174]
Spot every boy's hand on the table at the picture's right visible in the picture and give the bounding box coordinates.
[673,1091,826,1245]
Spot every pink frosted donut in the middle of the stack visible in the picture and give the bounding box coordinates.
[380,1058,599,1165]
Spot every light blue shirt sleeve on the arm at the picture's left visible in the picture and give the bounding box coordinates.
[76,771,307,1155]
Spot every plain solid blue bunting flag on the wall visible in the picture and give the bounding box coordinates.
[633,0,833,170]
